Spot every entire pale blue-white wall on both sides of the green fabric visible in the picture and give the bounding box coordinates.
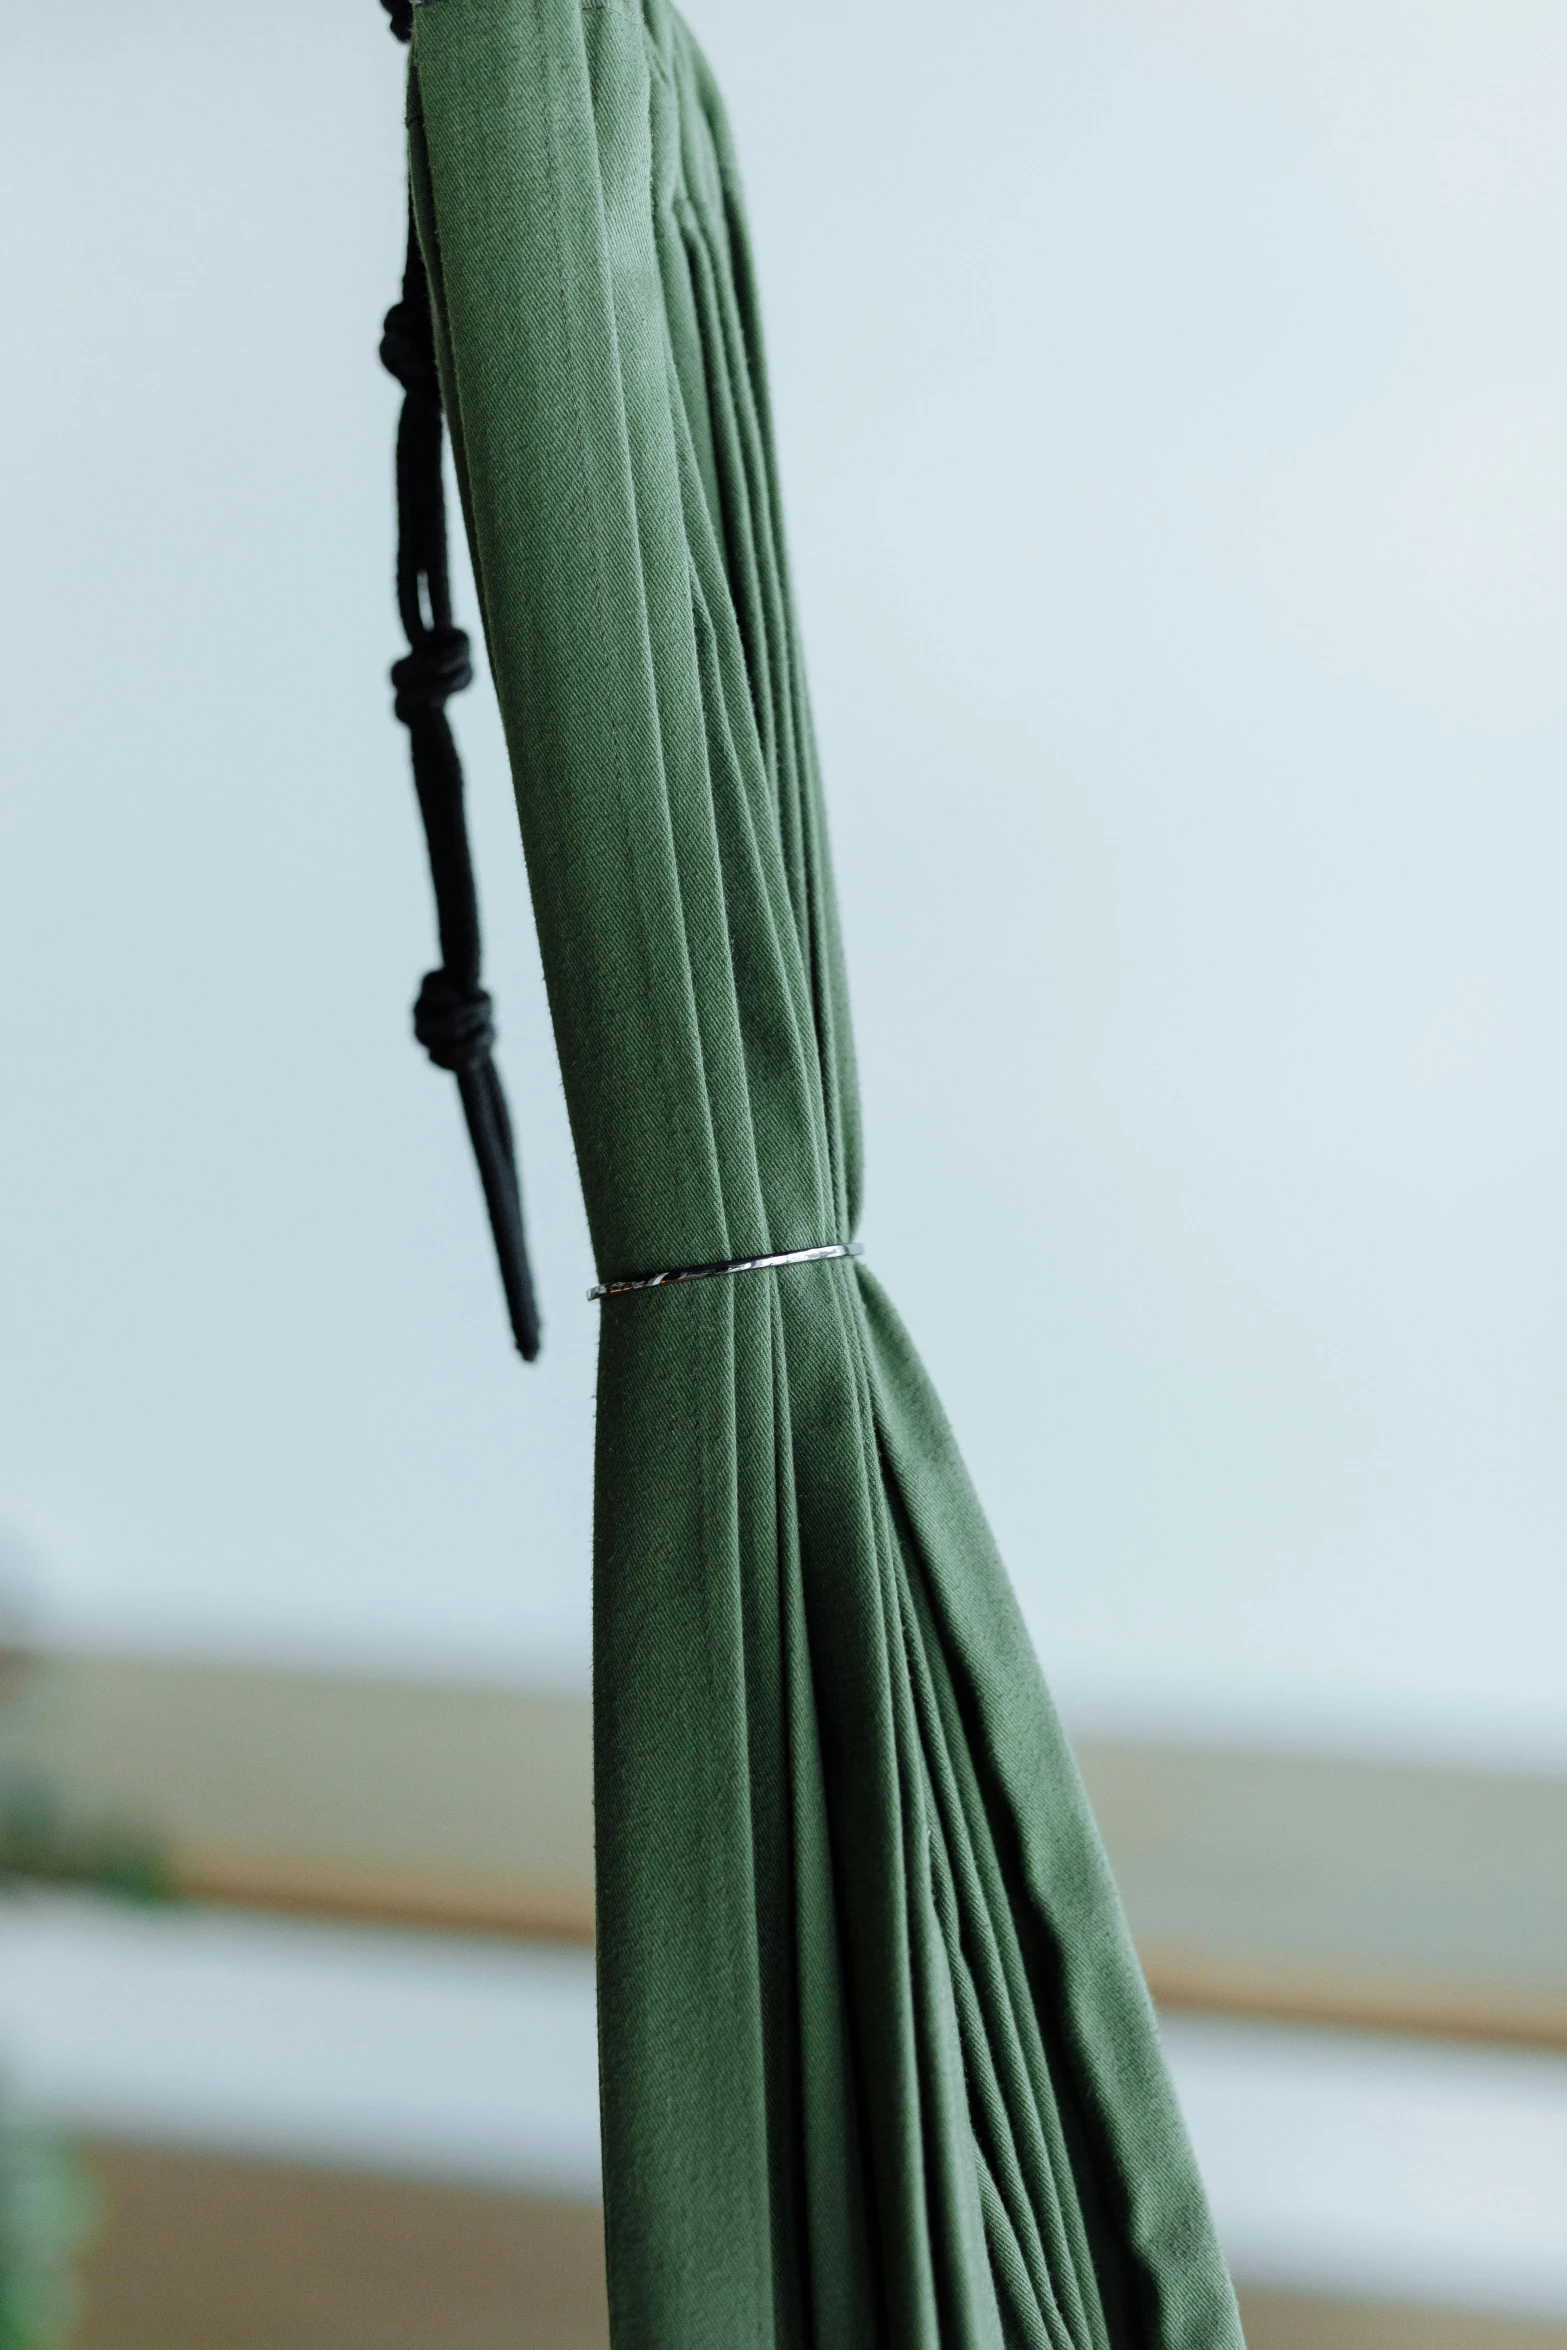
[0,0,1567,1763]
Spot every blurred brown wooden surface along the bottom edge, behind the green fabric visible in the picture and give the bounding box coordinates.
[75,2146,1567,2350]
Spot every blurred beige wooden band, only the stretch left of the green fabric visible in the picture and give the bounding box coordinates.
[0,1657,592,1941]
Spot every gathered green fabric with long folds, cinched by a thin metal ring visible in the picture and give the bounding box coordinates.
[409,0,1240,2350]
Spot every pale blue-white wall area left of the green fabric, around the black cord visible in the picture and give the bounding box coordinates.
[0,0,594,1673]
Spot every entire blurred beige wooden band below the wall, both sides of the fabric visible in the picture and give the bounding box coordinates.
[0,1657,1567,2047]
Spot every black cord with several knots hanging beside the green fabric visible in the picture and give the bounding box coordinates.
[381,0,540,1363]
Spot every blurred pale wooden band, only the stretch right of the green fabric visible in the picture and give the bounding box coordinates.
[1078,1739,1567,2047]
